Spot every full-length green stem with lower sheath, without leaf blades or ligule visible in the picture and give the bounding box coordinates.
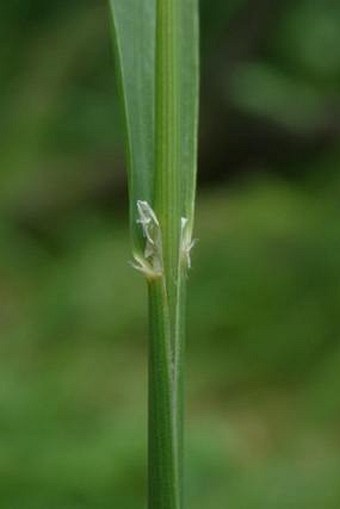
[149,0,186,509]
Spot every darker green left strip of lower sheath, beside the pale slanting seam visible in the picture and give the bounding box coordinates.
[148,277,180,509]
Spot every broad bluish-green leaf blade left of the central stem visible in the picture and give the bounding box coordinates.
[110,0,156,251]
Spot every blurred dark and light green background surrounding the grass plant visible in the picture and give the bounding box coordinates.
[0,0,340,509]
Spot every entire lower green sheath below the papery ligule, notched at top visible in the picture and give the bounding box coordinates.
[149,278,184,509]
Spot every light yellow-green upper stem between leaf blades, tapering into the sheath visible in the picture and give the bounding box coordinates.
[154,0,181,300]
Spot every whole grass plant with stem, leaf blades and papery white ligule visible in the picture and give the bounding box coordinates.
[110,0,198,509]
